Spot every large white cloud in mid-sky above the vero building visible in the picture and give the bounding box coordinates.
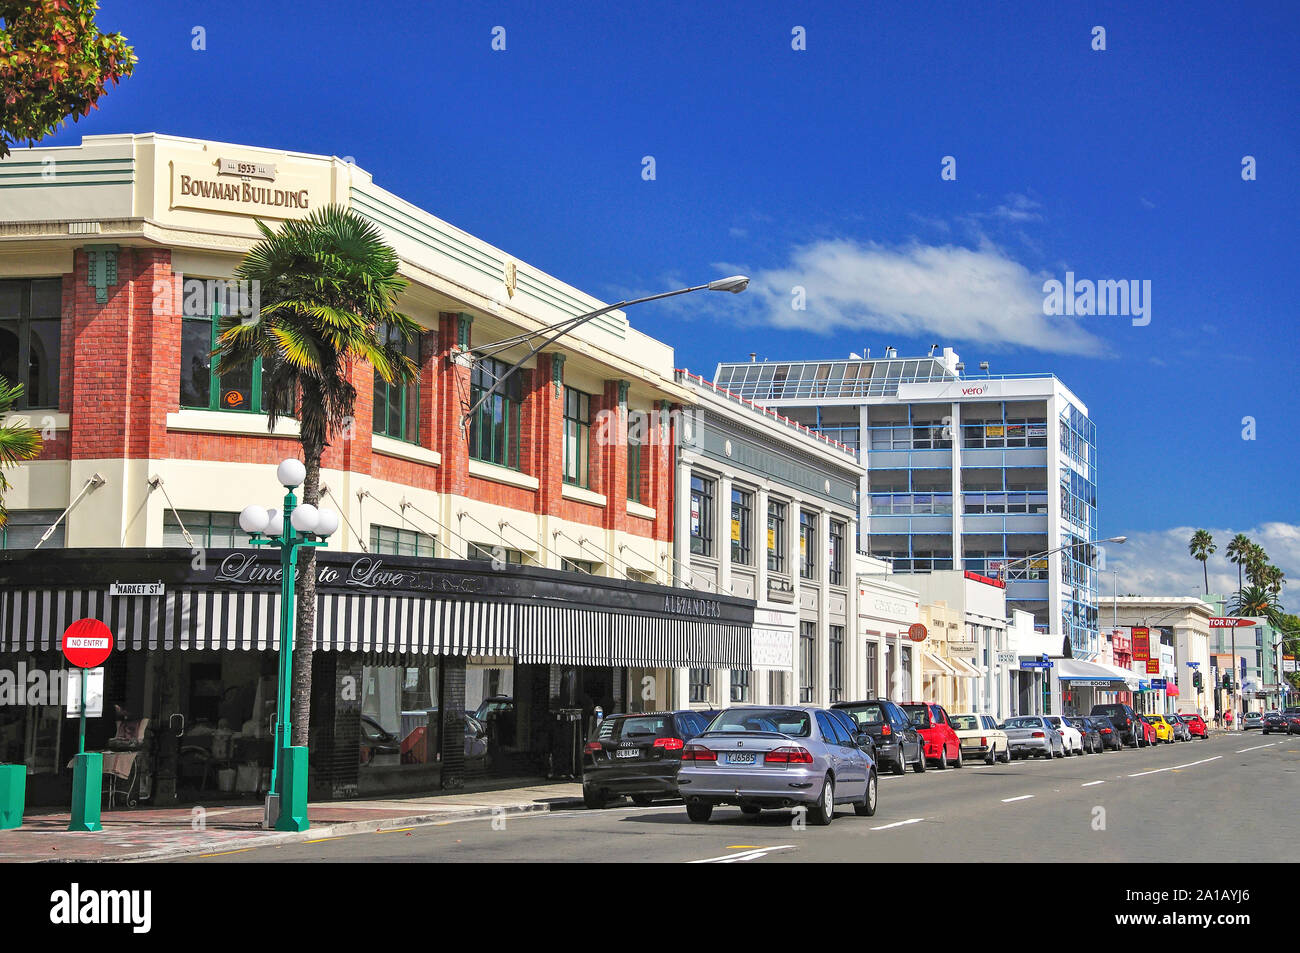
[750,239,1106,355]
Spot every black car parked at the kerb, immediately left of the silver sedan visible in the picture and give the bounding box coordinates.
[582,711,710,809]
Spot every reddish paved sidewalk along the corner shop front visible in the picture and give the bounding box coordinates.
[0,781,582,863]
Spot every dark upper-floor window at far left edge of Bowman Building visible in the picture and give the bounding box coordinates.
[0,278,62,408]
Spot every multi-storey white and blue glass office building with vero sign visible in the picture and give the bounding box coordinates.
[715,348,1101,659]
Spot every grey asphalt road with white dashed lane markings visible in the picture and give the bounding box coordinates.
[177,732,1300,863]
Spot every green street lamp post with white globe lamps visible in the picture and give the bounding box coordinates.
[239,459,338,831]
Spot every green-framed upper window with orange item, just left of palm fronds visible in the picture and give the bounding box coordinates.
[181,281,261,413]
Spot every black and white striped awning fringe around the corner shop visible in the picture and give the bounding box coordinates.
[0,589,751,670]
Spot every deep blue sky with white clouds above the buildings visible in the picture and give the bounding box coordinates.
[40,0,1300,589]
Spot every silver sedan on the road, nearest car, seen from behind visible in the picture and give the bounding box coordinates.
[677,705,878,826]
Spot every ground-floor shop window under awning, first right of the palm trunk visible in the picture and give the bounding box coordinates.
[360,664,439,771]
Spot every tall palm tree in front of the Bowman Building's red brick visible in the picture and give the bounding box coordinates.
[215,205,420,746]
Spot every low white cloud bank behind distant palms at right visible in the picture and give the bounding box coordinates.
[1099,523,1300,603]
